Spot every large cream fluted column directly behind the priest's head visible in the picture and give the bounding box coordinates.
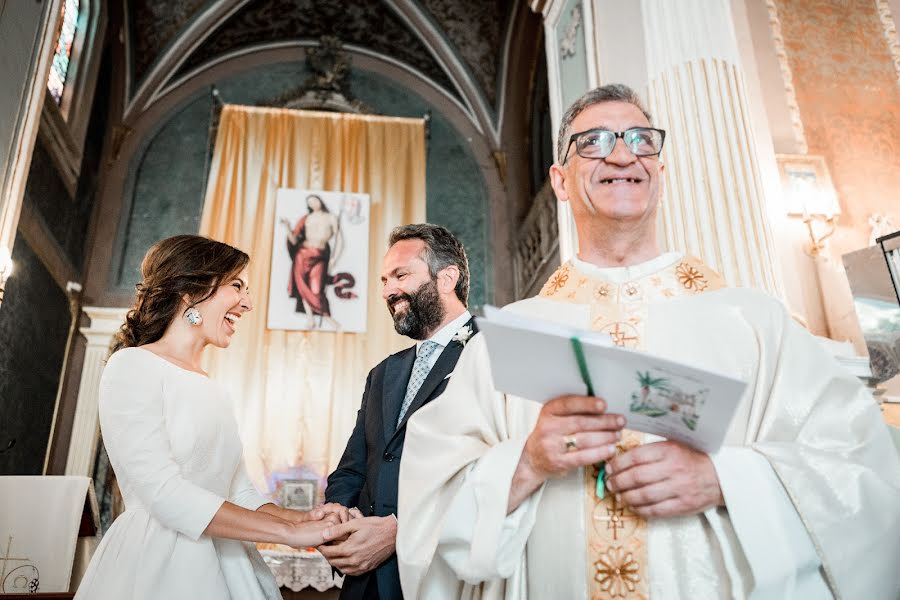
[642,0,784,297]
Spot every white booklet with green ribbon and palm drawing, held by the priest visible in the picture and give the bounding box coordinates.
[477,306,747,452]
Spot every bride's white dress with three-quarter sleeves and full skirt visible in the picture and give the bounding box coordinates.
[75,348,281,600]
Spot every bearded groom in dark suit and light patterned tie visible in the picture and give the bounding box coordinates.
[319,224,475,600]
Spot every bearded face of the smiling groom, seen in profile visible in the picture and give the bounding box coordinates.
[381,240,446,340]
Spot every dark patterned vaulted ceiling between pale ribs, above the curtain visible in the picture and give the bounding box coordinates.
[126,0,514,105]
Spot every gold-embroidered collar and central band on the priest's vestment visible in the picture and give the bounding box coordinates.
[540,257,724,600]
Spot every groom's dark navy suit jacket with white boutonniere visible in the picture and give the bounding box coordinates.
[325,319,476,600]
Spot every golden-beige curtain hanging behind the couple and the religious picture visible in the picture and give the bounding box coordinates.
[200,105,425,491]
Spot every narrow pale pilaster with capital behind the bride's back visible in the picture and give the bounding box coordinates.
[66,306,128,477]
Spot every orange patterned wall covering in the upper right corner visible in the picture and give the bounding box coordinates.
[777,0,900,258]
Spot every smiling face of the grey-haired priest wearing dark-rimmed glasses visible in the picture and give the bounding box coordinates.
[553,102,663,227]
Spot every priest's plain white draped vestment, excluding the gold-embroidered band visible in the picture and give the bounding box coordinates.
[397,254,900,600]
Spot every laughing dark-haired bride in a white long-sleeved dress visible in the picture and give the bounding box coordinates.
[75,235,348,600]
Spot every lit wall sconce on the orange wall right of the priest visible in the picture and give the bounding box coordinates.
[775,154,841,257]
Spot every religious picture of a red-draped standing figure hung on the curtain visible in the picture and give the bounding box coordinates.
[268,188,369,332]
